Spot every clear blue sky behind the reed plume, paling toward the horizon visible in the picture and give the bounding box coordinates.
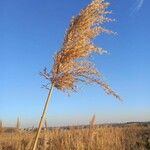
[0,0,150,127]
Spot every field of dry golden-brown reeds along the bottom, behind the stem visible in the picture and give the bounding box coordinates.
[0,124,150,150]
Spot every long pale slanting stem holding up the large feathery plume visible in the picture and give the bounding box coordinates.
[32,84,54,150]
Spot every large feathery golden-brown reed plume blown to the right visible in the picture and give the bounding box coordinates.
[42,0,120,99]
